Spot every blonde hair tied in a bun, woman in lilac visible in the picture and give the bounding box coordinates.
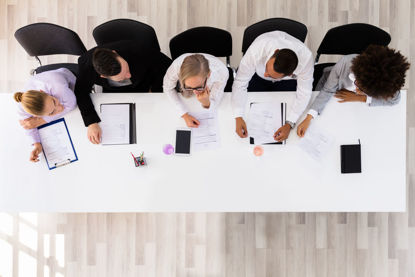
[13,90,48,115]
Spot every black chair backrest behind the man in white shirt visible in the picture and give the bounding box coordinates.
[242,18,307,54]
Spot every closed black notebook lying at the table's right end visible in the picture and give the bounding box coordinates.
[340,144,362,173]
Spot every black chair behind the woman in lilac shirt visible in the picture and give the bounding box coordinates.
[14,23,86,75]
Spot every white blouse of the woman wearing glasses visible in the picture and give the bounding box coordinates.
[163,53,229,116]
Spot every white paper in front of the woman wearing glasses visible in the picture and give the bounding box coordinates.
[191,111,220,151]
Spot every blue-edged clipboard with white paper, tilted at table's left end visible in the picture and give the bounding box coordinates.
[38,118,78,170]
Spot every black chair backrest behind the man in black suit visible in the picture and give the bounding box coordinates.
[92,18,160,51]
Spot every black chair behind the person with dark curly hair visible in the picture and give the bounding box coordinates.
[313,23,391,90]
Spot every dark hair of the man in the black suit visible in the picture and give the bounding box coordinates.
[92,48,121,76]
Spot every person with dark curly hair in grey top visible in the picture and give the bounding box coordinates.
[297,45,409,137]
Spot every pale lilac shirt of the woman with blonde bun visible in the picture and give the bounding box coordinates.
[17,68,76,143]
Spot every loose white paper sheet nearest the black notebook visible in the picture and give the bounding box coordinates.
[298,125,334,162]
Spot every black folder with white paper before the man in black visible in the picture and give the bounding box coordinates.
[100,103,137,145]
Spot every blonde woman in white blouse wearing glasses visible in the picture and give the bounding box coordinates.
[163,53,229,127]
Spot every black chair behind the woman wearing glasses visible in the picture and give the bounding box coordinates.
[169,27,235,92]
